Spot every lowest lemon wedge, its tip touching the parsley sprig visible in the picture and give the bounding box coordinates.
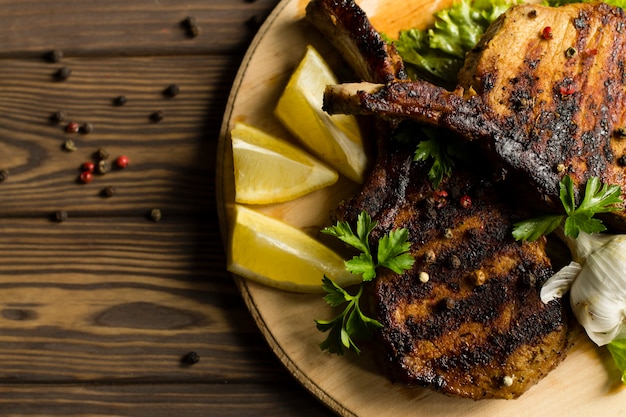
[227,204,361,292]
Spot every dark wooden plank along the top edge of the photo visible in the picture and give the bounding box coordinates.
[0,0,278,58]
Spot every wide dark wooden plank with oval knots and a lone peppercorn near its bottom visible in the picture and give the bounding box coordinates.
[0,218,294,383]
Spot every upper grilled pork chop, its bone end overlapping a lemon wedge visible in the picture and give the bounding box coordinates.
[325,3,626,229]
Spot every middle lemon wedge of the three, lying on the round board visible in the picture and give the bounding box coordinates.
[231,123,339,204]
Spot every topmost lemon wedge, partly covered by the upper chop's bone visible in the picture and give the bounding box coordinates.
[274,46,368,183]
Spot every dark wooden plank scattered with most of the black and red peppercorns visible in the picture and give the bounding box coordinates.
[0,55,239,217]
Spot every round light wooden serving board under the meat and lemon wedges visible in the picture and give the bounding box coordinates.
[217,0,626,417]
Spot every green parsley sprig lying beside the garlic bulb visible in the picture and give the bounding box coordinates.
[513,175,624,241]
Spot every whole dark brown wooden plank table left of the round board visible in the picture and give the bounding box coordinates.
[0,0,332,417]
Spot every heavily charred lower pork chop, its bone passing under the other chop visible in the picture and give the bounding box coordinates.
[307,0,569,399]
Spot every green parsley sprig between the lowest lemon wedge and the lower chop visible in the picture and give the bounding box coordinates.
[315,212,415,355]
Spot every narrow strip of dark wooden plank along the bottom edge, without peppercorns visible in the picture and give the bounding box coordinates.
[0,381,334,417]
